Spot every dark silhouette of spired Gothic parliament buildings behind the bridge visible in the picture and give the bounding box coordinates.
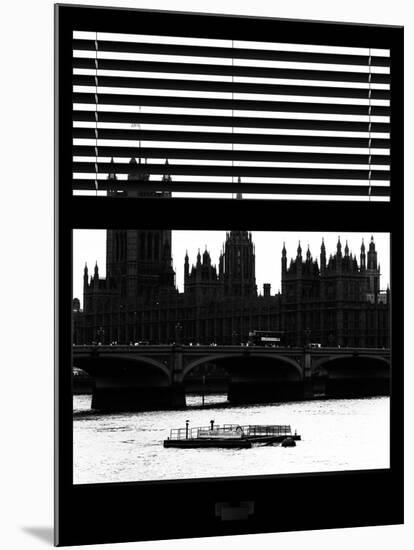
[73,154,390,347]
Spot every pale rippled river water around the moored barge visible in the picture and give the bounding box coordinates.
[73,395,390,484]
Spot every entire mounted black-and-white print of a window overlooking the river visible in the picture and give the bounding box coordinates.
[55,6,403,545]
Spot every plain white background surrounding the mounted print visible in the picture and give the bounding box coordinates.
[0,0,414,550]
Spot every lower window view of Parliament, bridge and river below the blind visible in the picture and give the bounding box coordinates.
[73,229,391,483]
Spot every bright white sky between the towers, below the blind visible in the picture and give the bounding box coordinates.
[73,229,390,304]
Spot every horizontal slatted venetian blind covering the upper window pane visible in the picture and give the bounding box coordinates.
[73,31,390,201]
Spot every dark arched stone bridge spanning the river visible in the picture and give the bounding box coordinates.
[73,344,391,411]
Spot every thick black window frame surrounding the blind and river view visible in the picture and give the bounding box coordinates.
[55,5,404,546]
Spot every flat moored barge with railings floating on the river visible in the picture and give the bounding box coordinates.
[164,420,300,449]
